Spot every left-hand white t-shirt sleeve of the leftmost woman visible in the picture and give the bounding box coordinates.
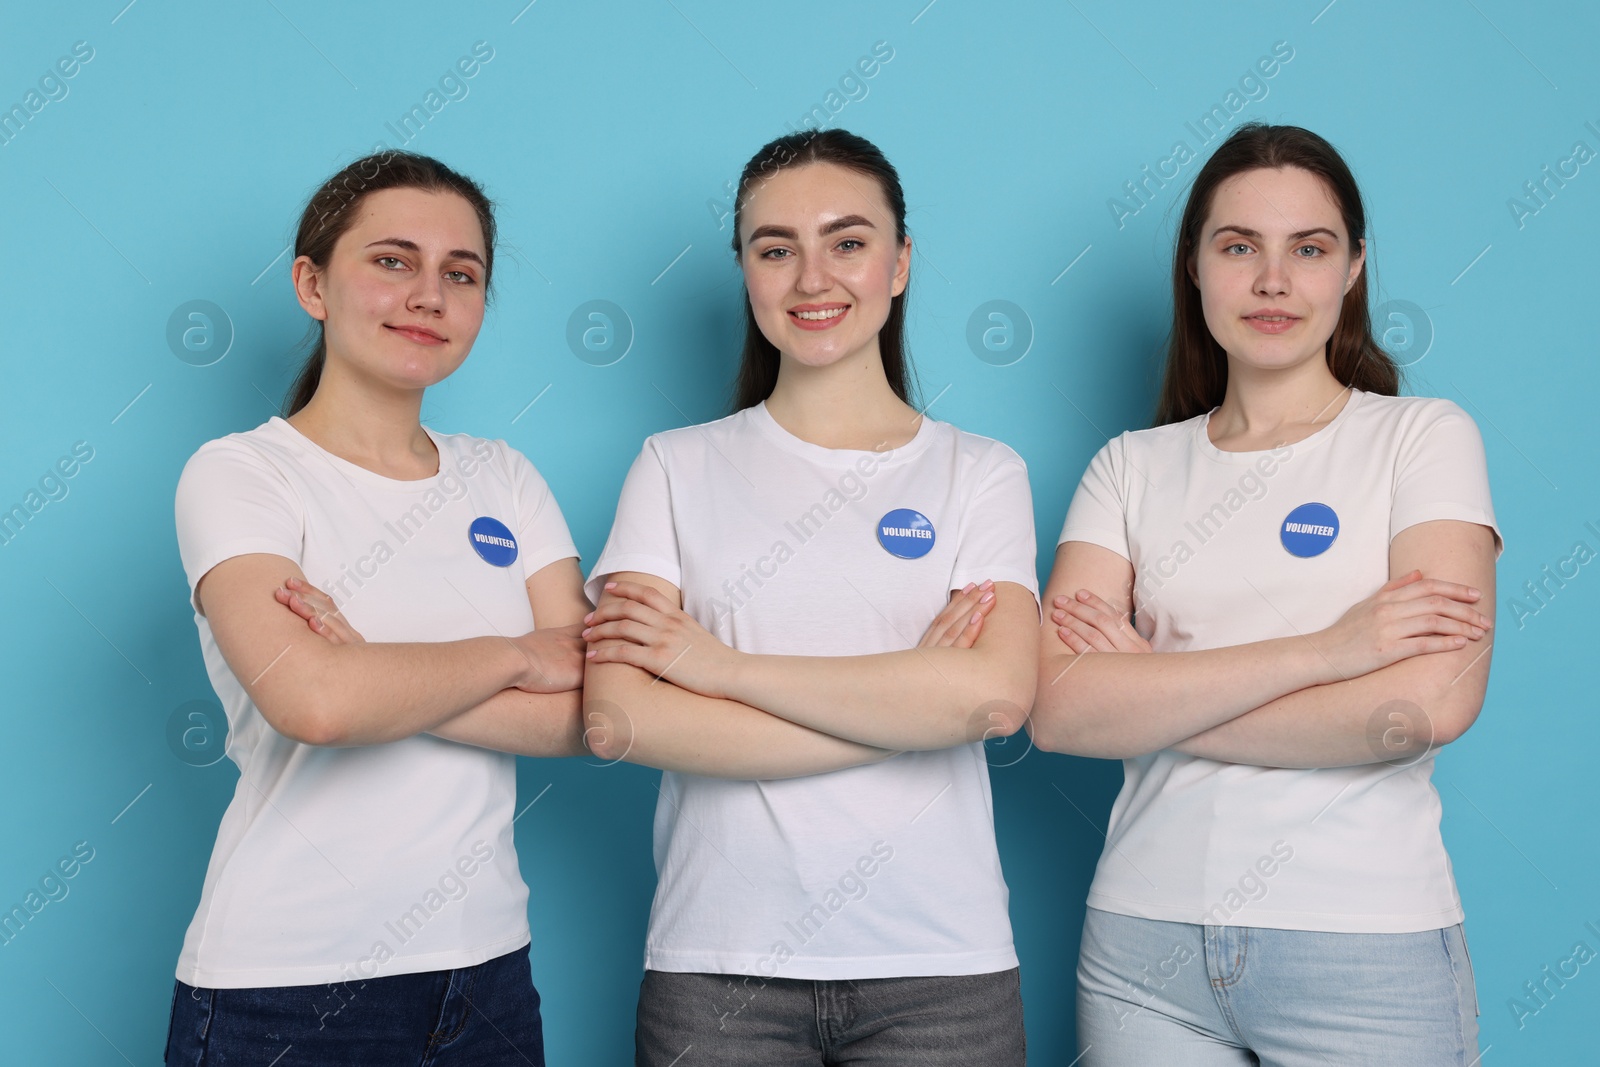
[173,437,306,613]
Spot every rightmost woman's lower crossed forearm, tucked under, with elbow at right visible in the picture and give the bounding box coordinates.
[1171,648,1490,768]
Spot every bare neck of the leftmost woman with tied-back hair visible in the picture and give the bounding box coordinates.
[288,354,438,477]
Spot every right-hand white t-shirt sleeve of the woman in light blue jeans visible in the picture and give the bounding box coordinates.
[1389,400,1506,558]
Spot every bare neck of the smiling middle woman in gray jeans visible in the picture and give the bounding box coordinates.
[766,342,922,451]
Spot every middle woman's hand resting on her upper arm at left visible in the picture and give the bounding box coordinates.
[582,582,739,699]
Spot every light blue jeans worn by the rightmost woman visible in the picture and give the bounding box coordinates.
[1078,907,1478,1067]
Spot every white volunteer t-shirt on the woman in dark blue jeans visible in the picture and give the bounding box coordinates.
[176,418,578,989]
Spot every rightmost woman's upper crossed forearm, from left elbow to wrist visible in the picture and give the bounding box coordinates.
[1029,635,1334,760]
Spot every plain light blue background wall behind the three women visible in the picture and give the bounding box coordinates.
[0,0,1600,1067]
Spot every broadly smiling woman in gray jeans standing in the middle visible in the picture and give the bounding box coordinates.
[584,130,1038,1067]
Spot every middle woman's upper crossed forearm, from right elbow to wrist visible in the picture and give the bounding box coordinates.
[728,648,1034,750]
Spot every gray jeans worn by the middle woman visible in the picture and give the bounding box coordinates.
[634,968,1027,1067]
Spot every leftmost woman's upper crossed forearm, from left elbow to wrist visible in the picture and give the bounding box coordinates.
[246,632,526,745]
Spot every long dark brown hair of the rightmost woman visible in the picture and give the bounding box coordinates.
[1155,122,1400,426]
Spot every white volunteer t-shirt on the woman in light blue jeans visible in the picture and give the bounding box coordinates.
[1061,390,1499,933]
